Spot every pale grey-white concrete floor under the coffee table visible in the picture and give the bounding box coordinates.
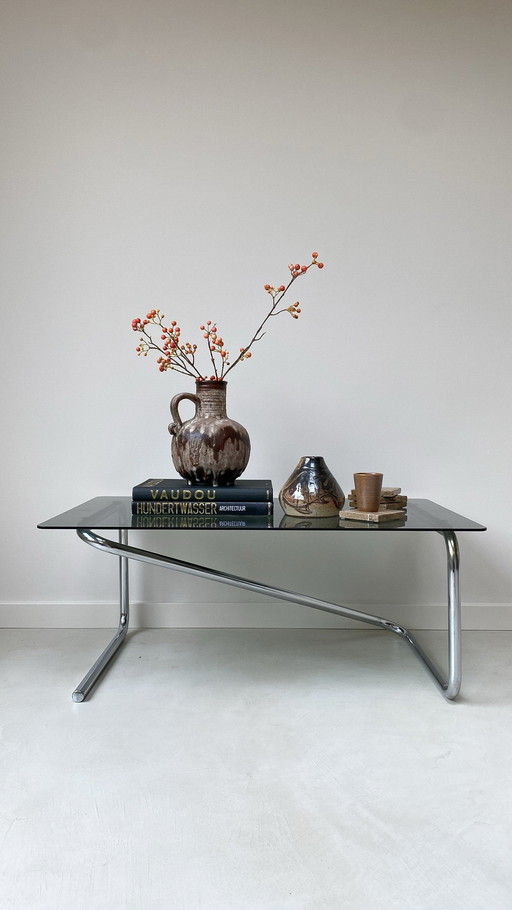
[0,629,512,910]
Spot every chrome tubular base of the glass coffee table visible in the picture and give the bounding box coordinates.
[73,528,461,702]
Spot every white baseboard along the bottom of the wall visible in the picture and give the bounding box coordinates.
[0,600,512,631]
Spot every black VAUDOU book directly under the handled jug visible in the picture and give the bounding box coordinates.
[132,477,273,502]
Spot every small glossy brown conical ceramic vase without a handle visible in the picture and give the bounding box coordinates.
[279,455,345,518]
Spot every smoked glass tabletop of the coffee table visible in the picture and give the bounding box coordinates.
[37,496,486,532]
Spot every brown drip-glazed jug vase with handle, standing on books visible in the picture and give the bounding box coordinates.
[169,379,251,487]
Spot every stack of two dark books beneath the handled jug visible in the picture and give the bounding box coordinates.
[132,477,274,527]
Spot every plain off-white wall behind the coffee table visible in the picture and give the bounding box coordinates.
[0,0,512,628]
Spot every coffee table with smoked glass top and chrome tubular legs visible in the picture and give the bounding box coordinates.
[38,496,486,702]
